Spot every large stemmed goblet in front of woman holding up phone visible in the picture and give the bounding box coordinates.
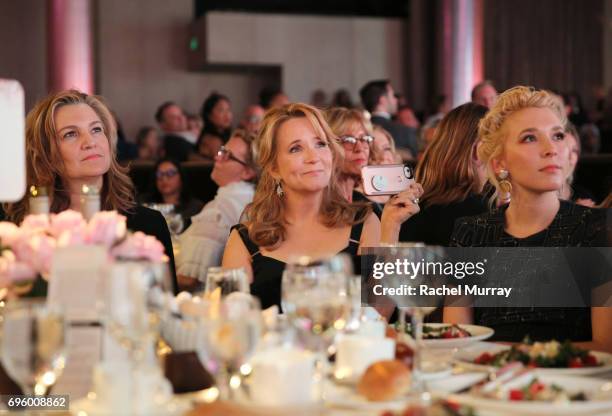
[282,257,351,400]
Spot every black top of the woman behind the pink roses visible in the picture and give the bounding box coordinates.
[122,205,178,294]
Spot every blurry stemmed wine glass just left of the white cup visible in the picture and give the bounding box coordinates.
[204,292,263,400]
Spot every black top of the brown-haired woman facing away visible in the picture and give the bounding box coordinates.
[399,194,489,246]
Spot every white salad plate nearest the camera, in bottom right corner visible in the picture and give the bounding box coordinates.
[448,370,612,416]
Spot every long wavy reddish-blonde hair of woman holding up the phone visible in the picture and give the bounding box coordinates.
[243,103,369,249]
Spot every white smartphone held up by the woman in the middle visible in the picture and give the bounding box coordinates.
[361,165,414,196]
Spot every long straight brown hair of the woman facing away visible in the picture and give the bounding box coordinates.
[415,103,488,206]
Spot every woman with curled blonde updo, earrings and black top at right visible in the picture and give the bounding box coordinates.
[444,87,612,350]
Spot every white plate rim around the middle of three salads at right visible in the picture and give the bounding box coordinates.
[455,342,612,376]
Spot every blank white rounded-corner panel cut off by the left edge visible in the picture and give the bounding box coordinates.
[0,79,26,202]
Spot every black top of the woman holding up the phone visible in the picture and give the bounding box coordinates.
[232,222,363,310]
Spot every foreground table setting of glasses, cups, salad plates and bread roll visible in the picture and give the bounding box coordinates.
[0,231,612,416]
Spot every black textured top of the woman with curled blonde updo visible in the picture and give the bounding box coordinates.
[450,201,609,342]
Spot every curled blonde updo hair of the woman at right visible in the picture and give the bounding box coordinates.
[478,86,567,201]
